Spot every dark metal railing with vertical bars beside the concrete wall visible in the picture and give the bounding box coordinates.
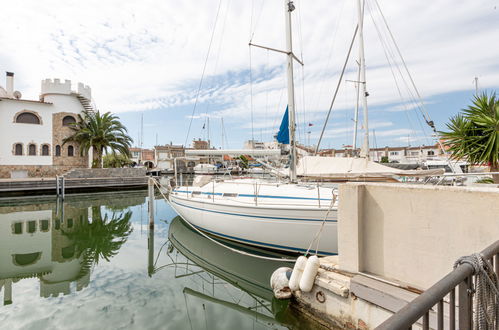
[376,240,499,330]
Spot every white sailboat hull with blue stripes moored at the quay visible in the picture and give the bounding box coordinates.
[169,186,337,255]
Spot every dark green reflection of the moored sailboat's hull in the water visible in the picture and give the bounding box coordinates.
[160,217,324,329]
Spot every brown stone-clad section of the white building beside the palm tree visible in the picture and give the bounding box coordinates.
[52,112,88,168]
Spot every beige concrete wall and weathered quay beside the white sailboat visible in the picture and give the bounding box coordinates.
[294,183,499,329]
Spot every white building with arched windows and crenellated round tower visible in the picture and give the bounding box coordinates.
[0,72,93,178]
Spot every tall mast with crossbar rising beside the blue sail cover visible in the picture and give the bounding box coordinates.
[284,0,296,182]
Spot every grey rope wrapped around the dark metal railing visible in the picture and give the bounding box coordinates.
[454,253,499,330]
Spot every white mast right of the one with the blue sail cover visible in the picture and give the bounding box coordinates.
[357,0,369,158]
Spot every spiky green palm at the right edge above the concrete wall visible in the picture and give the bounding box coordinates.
[440,93,499,183]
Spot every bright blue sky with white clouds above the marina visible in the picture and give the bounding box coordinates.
[0,0,499,148]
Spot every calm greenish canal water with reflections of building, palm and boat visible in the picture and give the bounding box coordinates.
[0,192,326,329]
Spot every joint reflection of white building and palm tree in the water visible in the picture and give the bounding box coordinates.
[0,193,144,305]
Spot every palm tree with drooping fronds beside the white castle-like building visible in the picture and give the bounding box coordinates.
[63,111,133,167]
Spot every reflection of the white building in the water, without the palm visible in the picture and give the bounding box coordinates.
[0,204,90,305]
